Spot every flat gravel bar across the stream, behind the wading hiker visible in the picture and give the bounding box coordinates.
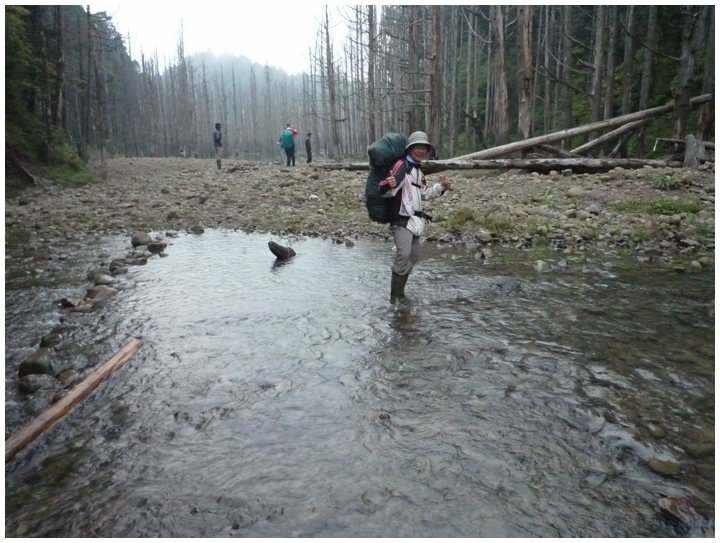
[5,158,715,262]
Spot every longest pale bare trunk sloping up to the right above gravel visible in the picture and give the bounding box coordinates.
[450,94,713,160]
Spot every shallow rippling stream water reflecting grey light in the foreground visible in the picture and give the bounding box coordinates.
[6,228,714,537]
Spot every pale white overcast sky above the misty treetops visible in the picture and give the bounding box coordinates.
[90,0,345,74]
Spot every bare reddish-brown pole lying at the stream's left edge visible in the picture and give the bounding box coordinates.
[5,339,142,464]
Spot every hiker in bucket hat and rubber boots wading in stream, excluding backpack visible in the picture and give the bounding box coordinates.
[379,132,452,305]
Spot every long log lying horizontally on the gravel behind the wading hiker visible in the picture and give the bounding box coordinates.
[315,158,667,174]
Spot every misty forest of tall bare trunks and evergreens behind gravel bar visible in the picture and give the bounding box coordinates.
[5,5,715,175]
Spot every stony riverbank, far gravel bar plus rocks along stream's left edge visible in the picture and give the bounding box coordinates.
[5,158,715,436]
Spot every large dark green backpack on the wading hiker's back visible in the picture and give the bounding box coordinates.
[365,132,407,223]
